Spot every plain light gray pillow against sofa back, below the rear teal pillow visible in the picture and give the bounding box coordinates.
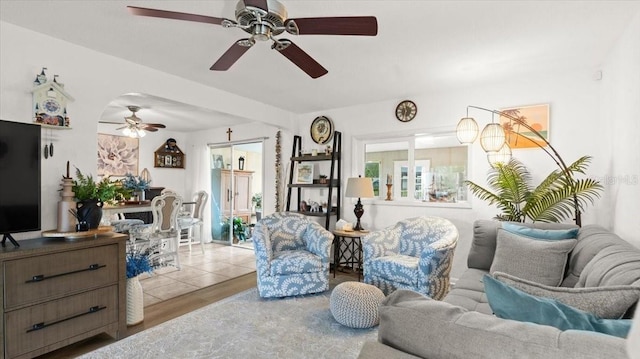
[489,229,578,287]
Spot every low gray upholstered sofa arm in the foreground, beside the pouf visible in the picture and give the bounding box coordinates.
[378,290,626,359]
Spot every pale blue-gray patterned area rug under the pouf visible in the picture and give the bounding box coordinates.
[80,286,377,359]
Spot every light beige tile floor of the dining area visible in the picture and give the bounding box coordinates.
[140,243,256,307]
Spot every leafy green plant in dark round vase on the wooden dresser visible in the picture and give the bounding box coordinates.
[72,168,118,230]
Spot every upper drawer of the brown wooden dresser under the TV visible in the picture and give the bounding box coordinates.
[4,245,118,310]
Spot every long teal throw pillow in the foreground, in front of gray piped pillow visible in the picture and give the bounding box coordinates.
[483,274,631,338]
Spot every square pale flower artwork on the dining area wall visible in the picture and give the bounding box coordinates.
[98,133,140,177]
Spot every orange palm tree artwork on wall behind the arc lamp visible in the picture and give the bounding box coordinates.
[500,104,549,149]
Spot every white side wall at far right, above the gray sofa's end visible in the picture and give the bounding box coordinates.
[598,14,640,247]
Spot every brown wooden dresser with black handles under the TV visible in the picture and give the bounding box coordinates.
[0,234,128,359]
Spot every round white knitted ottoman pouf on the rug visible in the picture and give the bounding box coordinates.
[329,282,384,328]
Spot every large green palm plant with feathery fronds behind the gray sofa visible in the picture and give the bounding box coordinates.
[465,156,603,222]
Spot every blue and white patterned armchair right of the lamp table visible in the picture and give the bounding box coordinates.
[362,217,458,300]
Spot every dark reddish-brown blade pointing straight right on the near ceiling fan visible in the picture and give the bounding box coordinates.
[285,16,378,36]
